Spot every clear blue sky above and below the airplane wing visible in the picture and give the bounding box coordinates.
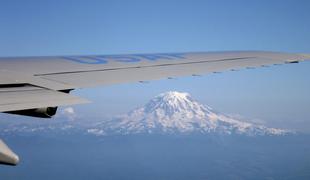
[0,0,310,132]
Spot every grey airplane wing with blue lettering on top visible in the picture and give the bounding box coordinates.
[0,51,310,117]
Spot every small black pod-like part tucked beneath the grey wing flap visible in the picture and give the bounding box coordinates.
[6,107,58,118]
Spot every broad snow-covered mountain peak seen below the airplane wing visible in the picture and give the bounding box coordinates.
[89,91,289,135]
